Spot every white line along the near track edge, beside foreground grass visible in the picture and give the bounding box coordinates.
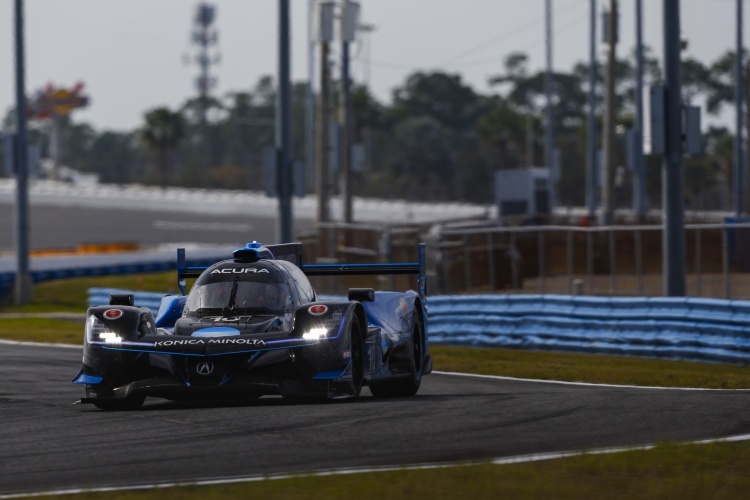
[0,434,750,499]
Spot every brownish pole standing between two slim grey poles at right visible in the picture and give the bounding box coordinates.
[601,0,618,226]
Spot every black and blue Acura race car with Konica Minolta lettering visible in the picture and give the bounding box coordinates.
[73,242,432,410]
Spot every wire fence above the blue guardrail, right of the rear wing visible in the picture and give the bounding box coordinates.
[438,219,750,299]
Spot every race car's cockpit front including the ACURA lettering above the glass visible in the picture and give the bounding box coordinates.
[184,261,291,317]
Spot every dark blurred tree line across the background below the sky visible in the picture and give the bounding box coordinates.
[3,50,750,209]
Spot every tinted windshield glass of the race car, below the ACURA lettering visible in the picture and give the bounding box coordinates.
[185,266,291,316]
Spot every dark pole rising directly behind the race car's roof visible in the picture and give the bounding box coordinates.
[276,0,293,243]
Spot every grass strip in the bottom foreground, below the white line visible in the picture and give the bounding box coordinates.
[35,443,750,500]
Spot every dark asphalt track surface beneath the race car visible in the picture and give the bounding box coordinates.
[0,344,750,495]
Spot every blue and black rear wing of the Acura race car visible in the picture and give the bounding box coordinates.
[177,243,427,299]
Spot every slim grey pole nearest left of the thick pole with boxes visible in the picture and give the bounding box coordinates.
[633,0,647,222]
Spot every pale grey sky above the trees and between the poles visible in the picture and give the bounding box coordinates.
[0,0,750,131]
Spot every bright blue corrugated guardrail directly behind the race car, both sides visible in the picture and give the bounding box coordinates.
[89,288,750,364]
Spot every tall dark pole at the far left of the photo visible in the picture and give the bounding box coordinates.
[14,0,32,305]
